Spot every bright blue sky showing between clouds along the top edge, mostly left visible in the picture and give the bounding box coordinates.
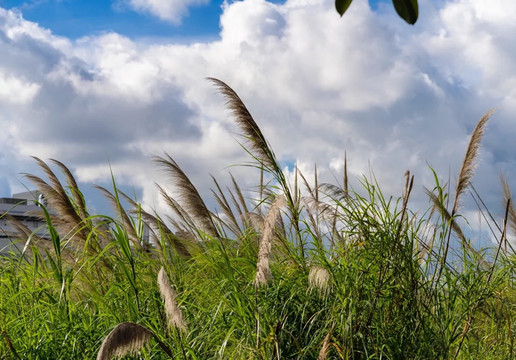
[0,0,388,41]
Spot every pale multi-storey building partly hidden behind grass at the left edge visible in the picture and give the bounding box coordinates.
[0,191,48,254]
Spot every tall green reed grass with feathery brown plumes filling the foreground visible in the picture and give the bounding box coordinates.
[0,79,516,360]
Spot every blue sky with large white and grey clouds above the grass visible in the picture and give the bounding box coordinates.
[0,0,516,242]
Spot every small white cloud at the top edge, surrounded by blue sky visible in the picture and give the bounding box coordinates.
[123,0,209,25]
